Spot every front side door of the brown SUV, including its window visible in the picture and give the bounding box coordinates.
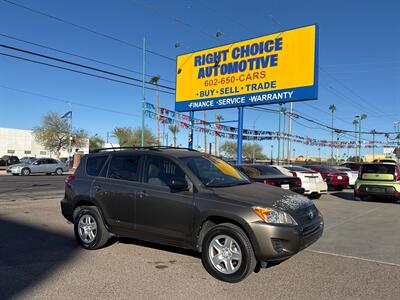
[136,155,195,245]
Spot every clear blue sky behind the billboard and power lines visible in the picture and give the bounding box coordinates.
[0,0,400,155]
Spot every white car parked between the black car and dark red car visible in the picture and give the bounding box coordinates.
[273,166,328,199]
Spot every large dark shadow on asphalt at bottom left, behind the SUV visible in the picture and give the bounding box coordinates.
[0,219,80,299]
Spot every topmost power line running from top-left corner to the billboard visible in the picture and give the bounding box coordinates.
[3,0,175,62]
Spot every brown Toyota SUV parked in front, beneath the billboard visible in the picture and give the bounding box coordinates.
[61,147,324,282]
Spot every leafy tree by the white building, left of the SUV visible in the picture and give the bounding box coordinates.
[33,112,88,158]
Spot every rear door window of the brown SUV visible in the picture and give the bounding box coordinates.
[108,155,140,181]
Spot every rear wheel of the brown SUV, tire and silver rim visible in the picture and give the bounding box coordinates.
[74,206,110,250]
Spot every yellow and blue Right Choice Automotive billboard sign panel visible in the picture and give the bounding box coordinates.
[175,25,318,111]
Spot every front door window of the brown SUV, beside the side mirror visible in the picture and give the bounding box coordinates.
[144,156,185,186]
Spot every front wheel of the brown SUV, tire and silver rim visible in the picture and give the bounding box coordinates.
[202,223,257,283]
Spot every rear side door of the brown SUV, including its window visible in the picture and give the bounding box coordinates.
[91,153,143,235]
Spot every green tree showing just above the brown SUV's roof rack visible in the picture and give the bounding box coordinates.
[113,127,157,147]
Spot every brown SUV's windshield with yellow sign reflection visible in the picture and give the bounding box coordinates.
[181,156,250,187]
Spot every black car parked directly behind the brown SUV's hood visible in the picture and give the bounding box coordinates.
[236,164,304,194]
